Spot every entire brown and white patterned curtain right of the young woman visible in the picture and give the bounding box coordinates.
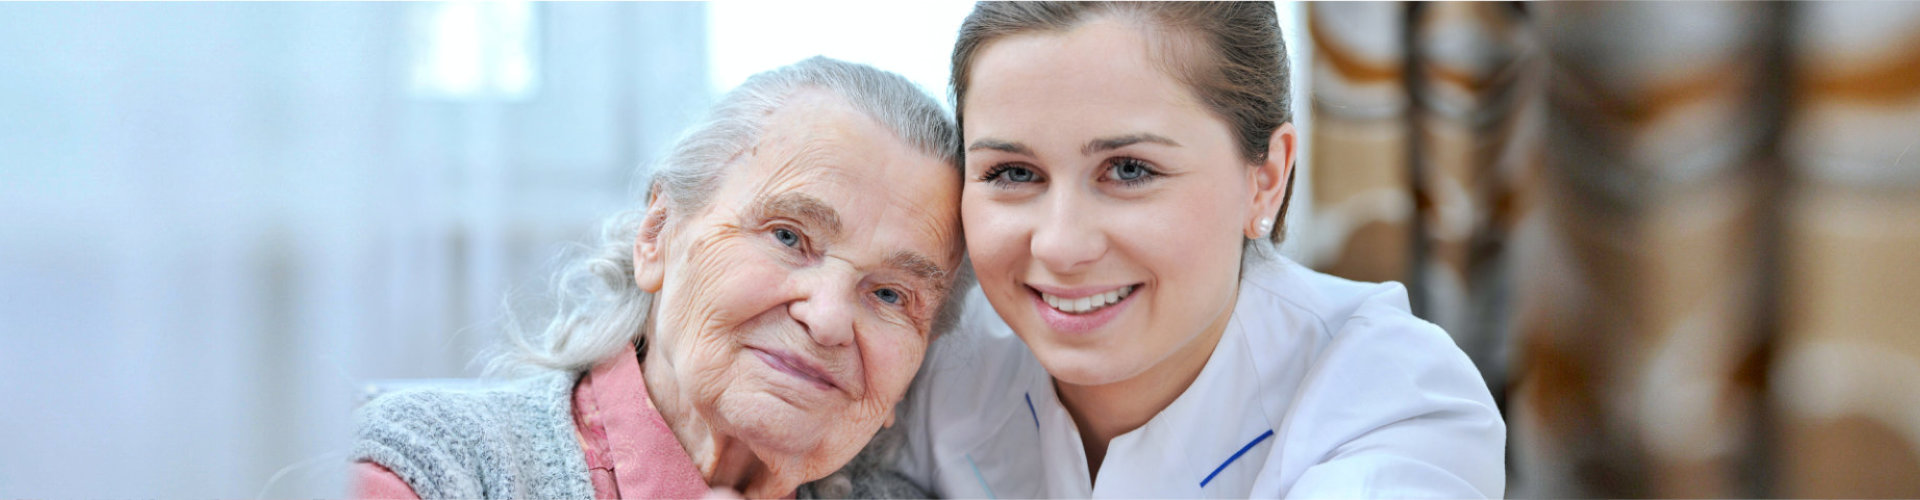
[1308,2,1920,498]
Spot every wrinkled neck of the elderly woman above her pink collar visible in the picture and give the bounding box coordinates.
[639,338,801,498]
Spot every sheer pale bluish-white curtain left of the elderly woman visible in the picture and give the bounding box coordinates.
[0,4,712,498]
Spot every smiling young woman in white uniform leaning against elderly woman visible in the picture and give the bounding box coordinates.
[883,2,1505,498]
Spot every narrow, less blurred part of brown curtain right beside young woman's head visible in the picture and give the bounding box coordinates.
[1308,2,1544,425]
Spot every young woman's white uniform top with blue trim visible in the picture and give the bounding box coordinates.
[899,260,1507,498]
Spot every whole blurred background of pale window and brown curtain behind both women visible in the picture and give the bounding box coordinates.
[0,2,1920,498]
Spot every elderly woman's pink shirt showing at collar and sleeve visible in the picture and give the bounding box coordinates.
[353,346,708,498]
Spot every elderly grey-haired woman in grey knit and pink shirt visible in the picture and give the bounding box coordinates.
[355,58,964,498]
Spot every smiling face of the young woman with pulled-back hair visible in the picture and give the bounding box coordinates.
[960,19,1258,385]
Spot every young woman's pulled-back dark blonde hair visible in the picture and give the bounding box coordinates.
[952,2,1294,244]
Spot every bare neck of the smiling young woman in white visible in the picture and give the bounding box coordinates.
[1054,292,1238,479]
